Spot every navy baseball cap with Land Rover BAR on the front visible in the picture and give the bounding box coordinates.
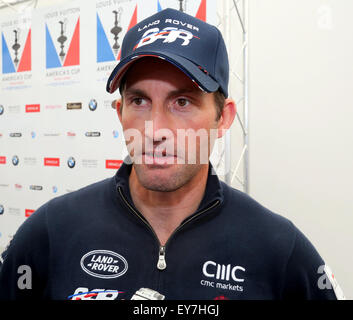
[106,8,229,97]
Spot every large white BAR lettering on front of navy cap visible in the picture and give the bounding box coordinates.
[134,27,200,51]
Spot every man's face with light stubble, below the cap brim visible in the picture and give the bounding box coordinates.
[117,58,223,191]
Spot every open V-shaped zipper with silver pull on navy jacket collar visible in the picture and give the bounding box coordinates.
[118,187,220,271]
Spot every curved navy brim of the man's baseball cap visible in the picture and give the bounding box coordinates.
[106,51,219,93]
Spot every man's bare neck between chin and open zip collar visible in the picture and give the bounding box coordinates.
[129,165,208,245]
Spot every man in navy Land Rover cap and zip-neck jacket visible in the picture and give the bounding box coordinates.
[0,9,342,300]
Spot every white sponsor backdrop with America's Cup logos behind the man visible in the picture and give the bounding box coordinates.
[0,0,217,247]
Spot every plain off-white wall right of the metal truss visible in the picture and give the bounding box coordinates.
[249,0,353,299]
